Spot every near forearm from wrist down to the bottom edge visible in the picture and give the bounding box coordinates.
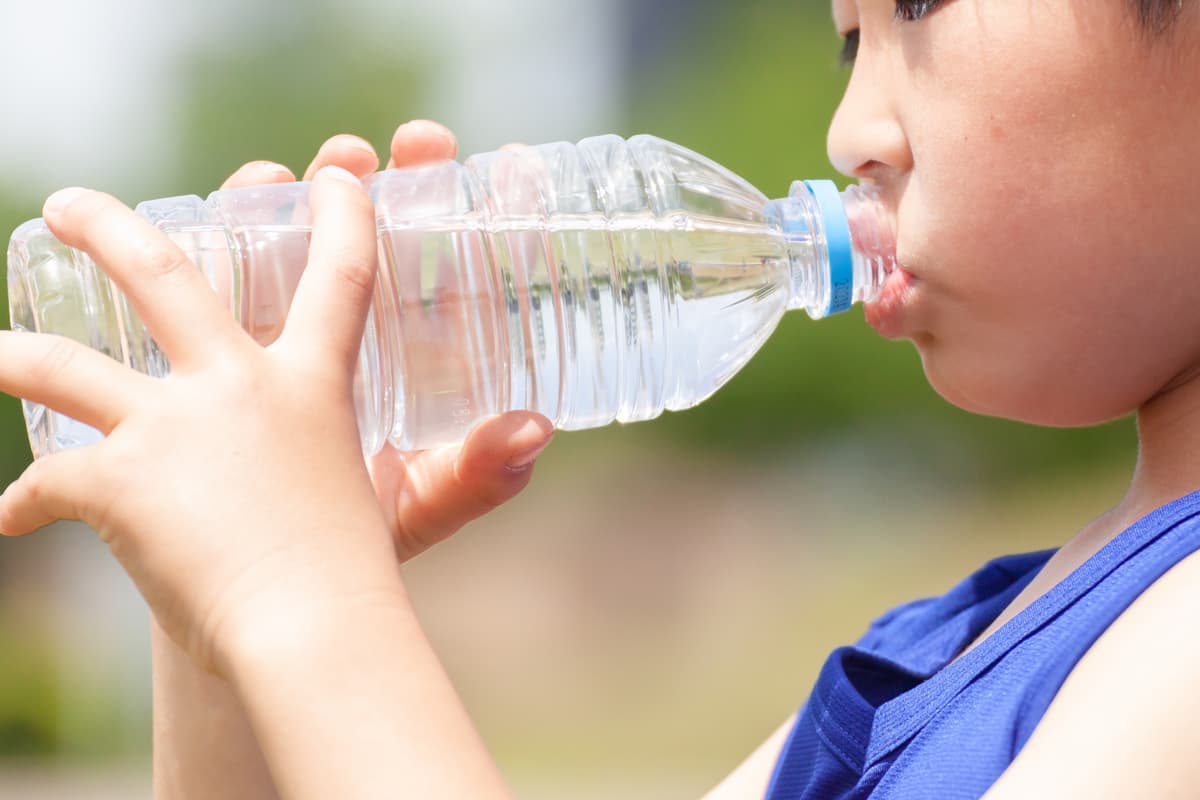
[226,582,510,800]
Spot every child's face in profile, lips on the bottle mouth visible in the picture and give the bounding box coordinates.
[829,0,1200,425]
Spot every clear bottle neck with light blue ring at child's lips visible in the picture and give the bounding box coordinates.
[764,181,895,319]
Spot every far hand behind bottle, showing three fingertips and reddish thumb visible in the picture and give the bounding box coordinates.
[221,120,553,560]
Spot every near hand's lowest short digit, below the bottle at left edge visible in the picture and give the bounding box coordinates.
[0,447,100,536]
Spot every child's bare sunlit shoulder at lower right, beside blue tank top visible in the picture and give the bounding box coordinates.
[986,553,1200,800]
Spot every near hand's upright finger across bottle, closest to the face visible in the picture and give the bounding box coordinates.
[281,167,378,372]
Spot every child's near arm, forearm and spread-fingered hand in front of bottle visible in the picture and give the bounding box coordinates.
[0,137,535,798]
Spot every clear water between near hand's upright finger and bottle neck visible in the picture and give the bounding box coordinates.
[369,212,788,449]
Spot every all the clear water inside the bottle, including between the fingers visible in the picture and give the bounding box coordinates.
[10,212,806,460]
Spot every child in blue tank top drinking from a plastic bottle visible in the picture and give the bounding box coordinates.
[0,0,1200,800]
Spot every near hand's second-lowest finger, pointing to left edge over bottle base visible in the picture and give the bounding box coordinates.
[0,331,152,434]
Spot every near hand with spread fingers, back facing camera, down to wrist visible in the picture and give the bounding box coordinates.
[0,167,453,673]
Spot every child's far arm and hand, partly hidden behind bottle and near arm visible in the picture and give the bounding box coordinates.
[151,121,550,800]
